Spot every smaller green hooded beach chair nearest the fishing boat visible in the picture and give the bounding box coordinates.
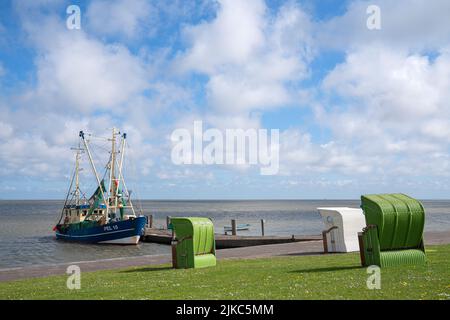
[170,218,216,269]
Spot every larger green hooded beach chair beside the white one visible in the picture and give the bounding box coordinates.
[358,194,425,267]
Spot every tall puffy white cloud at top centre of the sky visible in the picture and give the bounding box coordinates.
[180,0,312,116]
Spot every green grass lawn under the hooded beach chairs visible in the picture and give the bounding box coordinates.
[0,245,450,299]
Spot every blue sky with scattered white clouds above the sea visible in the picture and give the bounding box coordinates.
[0,0,450,199]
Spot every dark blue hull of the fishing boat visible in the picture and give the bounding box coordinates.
[56,217,146,243]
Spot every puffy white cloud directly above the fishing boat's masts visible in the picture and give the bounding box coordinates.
[10,1,150,113]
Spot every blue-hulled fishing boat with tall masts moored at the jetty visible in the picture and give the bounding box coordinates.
[53,128,146,244]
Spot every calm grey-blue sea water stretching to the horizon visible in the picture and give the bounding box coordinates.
[0,200,450,269]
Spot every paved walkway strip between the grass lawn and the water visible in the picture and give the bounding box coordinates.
[0,231,450,282]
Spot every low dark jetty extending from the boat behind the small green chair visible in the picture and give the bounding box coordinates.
[141,228,322,249]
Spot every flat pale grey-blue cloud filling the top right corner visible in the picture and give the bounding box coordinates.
[316,0,450,51]
